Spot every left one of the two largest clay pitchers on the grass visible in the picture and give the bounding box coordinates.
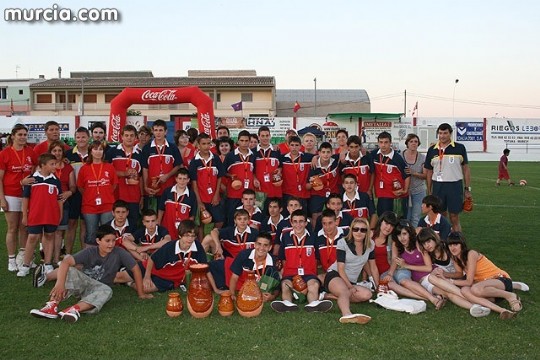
[187,264,214,318]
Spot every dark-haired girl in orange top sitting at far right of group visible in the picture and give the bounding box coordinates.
[448,232,522,319]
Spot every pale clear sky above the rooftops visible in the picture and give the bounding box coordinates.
[0,0,540,119]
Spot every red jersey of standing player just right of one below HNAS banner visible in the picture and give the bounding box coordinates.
[281,153,313,199]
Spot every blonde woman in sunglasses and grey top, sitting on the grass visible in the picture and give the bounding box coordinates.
[321,218,375,324]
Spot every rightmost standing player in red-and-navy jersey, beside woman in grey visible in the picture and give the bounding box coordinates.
[368,131,411,216]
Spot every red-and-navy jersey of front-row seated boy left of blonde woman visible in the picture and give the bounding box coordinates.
[278,231,317,277]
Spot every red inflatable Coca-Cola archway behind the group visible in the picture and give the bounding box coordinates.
[107,86,216,142]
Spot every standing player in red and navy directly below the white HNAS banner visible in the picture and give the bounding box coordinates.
[255,126,283,215]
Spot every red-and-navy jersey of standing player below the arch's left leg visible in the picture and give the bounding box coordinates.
[107,144,142,203]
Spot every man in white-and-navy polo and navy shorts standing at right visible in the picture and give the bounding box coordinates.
[424,123,472,231]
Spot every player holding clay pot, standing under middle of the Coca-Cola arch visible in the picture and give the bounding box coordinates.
[141,120,182,210]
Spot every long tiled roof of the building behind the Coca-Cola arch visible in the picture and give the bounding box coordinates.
[30,76,276,89]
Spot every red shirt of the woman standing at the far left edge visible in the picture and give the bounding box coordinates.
[0,146,37,197]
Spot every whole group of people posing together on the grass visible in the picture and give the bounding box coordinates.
[0,120,528,324]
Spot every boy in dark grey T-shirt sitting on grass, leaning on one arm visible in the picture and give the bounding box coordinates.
[30,225,153,323]
